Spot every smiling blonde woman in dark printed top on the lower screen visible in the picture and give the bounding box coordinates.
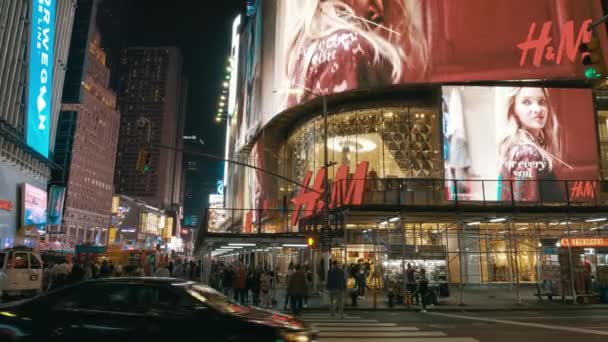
[498,88,567,202]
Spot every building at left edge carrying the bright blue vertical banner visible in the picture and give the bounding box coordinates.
[0,0,77,248]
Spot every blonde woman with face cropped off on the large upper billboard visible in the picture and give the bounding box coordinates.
[285,0,427,106]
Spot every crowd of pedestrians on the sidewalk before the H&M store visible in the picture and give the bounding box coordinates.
[209,260,429,315]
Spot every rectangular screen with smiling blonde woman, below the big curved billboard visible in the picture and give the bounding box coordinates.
[442,86,599,202]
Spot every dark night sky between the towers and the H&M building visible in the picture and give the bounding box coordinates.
[100,0,245,184]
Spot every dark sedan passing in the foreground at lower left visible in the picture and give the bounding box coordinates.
[0,278,316,342]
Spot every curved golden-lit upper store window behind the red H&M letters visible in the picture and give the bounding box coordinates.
[287,107,442,191]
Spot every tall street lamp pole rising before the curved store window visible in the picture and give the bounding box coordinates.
[274,84,330,280]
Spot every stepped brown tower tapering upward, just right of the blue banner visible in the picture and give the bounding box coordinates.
[50,0,120,246]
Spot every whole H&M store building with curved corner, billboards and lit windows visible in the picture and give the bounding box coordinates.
[205,0,608,299]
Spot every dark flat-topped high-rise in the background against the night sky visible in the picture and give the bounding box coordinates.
[115,47,187,209]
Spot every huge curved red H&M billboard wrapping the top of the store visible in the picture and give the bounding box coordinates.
[237,0,606,147]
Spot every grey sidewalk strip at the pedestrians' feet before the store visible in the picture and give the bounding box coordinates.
[275,286,608,311]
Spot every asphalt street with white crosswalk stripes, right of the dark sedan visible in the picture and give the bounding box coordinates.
[302,309,608,342]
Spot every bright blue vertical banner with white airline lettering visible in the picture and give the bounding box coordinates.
[26,0,56,158]
